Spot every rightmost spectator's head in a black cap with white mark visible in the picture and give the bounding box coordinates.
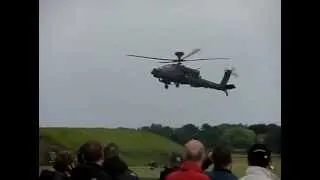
[248,144,271,168]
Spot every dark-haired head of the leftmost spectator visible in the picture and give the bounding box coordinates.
[53,151,74,172]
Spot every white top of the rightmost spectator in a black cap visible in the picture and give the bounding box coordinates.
[240,166,280,180]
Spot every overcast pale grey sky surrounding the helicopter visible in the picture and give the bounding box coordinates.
[39,0,281,127]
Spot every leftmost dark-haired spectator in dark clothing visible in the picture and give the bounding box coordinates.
[39,151,74,180]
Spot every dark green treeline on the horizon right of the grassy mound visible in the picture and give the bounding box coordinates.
[139,124,281,153]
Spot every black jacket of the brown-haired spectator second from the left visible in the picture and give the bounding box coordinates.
[71,163,112,180]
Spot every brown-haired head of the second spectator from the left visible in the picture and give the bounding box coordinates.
[81,140,104,164]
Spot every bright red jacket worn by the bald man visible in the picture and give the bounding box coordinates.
[166,161,210,180]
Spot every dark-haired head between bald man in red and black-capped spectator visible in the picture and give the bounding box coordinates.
[211,147,232,170]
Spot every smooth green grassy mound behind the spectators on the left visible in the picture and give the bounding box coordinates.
[39,128,182,166]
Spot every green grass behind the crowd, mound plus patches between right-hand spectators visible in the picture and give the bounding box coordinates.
[40,128,281,180]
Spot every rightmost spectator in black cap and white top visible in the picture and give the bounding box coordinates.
[240,144,280,180]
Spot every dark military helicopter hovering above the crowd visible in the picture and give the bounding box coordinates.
[127,49,237,96]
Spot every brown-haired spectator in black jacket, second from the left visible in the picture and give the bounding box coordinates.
[71,141,112,180]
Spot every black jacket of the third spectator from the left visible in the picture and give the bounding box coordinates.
[103,156,139,180]
